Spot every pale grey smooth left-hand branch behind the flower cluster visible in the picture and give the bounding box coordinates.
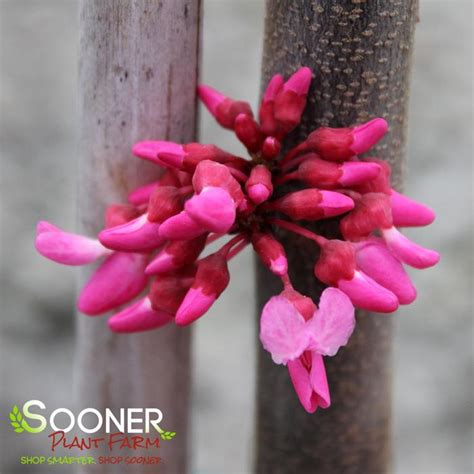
[76,0,200,473]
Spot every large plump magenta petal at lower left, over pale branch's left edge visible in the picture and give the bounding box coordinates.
[78,252,148,315]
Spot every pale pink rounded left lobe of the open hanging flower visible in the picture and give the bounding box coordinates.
[260,296,310,364]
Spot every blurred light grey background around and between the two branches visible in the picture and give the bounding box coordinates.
[0,0,473,474]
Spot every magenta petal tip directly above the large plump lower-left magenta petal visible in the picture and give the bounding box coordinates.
[99,214,165,252]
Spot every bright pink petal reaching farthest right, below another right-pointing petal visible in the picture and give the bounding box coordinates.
[382,227,439,269]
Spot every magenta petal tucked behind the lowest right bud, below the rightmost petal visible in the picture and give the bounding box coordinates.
[354,237,416,304]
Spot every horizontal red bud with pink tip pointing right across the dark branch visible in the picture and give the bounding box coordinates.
[269,189,354,220]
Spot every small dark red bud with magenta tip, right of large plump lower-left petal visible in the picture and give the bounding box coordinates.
[145,234,207,275]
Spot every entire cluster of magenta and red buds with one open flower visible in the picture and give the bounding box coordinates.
[36,67,439,412]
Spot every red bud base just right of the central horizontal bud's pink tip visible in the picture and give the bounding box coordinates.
[340,193,393,240]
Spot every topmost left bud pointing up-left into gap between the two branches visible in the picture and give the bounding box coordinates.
[198,85,253,129]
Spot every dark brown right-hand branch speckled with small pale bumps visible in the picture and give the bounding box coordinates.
[256,0,418,474]
